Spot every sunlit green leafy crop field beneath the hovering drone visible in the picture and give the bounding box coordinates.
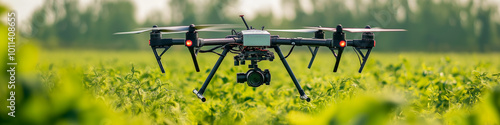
[2,45,500,125]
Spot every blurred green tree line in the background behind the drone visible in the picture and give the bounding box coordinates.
[24,0,500,52]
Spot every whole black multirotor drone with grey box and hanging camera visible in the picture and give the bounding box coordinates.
[115,15,406,102]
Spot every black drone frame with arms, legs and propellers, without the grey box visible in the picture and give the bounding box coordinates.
[116,15,405,102]
